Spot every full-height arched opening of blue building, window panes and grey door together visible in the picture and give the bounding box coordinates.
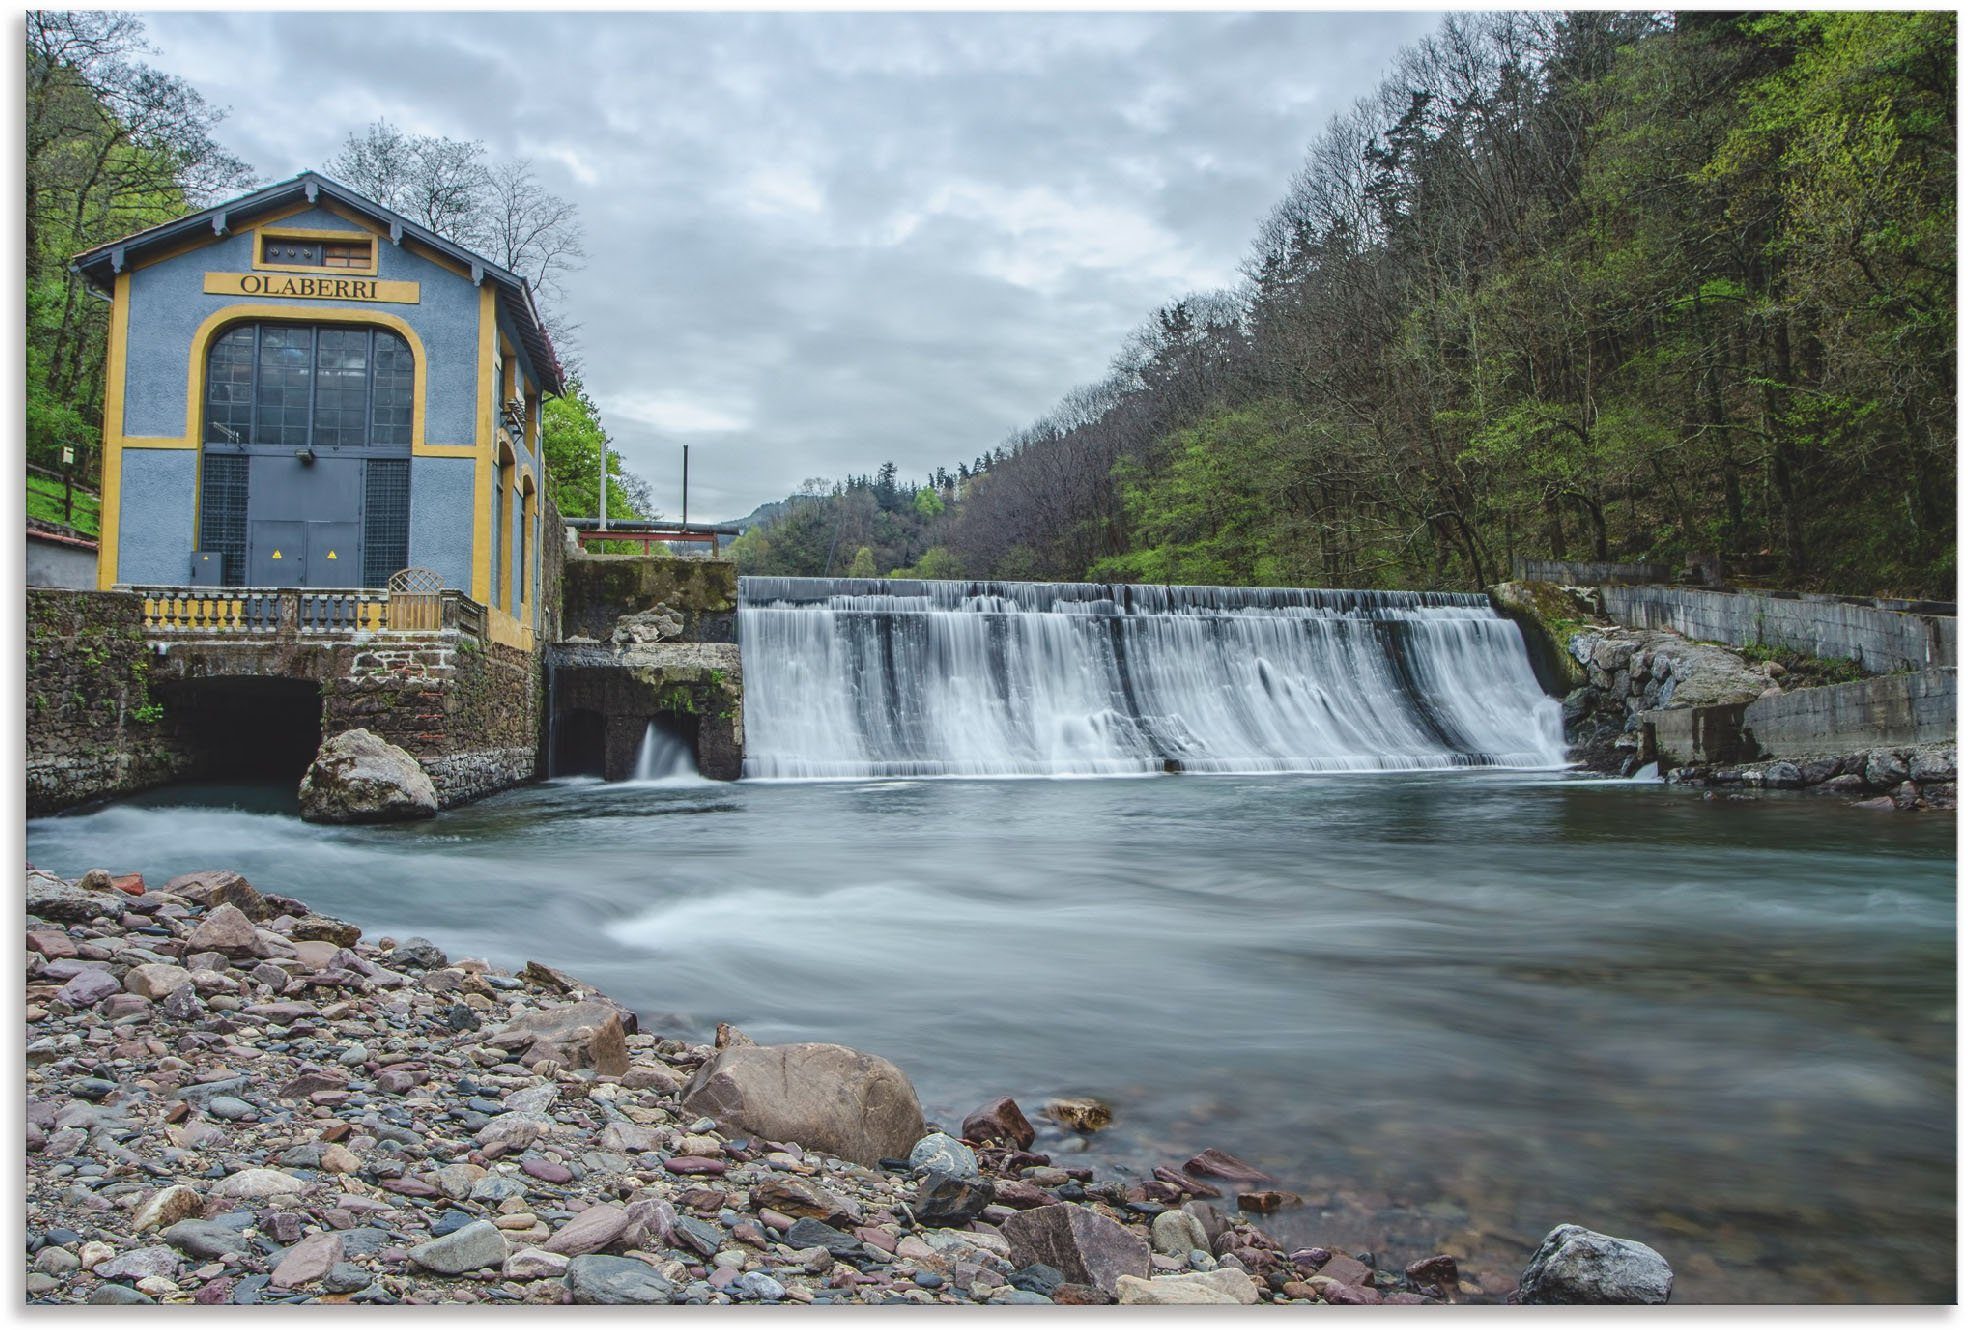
[199,323,415,586]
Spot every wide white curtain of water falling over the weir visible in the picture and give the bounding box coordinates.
[738,576,1565,779]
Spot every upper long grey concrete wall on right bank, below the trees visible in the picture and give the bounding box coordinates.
[1600,586,1956,673]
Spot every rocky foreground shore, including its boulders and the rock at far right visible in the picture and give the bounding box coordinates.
[26,868,1673,1304]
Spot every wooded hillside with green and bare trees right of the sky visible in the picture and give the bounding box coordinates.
[738,12,1956,598]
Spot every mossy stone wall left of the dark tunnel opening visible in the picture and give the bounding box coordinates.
[26,588,195,816]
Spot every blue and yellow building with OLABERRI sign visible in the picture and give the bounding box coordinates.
[75,171,563,649]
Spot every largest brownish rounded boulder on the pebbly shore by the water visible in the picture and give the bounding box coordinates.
[683,1043,923,1167]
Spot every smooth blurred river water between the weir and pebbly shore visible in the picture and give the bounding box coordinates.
[28,769,1954,1302]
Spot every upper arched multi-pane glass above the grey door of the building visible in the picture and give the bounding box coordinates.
[205,323,415,456]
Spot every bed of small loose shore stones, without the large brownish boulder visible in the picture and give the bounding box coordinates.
[28,861,1423,1306]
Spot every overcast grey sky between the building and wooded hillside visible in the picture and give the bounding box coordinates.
[134,12,1437,519]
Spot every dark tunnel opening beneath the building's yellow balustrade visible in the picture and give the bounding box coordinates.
[157,677,321,791]
